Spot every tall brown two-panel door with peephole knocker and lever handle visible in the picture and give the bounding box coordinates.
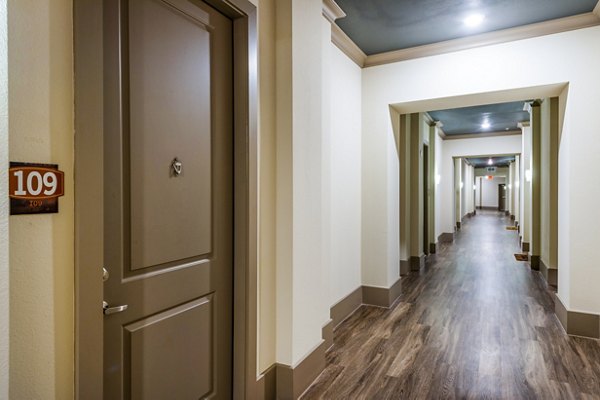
[104,0,233,400]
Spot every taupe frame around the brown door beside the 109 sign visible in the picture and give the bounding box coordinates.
[73,0,259,400]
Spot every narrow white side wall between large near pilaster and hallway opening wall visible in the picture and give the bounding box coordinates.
[328,43,362,304]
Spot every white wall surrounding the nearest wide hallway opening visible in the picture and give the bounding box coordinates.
[363,27,600,313]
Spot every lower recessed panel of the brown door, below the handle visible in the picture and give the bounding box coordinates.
[124,297,212,400]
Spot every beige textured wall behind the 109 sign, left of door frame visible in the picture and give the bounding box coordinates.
[8,0,74,399]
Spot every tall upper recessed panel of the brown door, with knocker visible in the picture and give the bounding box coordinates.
[128,0,211,270]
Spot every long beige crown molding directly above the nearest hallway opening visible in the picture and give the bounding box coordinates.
[364,11,600,68]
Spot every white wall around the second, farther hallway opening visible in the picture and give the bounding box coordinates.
[437,135,521,233]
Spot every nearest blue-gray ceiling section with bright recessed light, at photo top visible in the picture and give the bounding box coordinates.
[336,0,598,55]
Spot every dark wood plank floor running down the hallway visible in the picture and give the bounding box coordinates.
[303,211,600,400]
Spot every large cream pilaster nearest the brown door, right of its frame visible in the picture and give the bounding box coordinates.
[275,0,330,366]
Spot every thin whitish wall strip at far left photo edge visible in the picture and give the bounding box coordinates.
[0,0,9,400]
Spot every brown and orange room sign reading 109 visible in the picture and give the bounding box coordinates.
[8,162,65,215]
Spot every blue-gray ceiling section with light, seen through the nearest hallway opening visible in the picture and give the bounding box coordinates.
[429,101,529,136]
